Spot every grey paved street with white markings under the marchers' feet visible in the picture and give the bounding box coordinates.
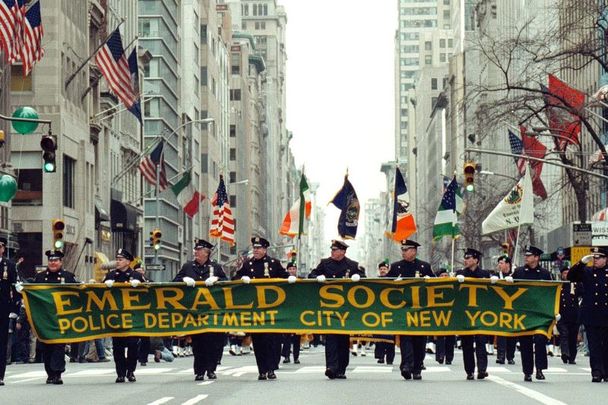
[0,346,608,405]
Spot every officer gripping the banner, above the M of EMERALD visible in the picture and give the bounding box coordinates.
[103,249,143,383]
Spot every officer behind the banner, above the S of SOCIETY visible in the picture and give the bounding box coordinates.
[308,240,365,380]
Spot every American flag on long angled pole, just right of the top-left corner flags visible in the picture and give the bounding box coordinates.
[95,28,138,109]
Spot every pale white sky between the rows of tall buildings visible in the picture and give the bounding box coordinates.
[278,0,398,256]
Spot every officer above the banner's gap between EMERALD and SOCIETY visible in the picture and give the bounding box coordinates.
[233,237,296,380]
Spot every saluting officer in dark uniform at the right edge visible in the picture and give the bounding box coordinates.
[568,246,608,382]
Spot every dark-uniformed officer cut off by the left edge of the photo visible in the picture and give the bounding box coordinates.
[0,238,19,386]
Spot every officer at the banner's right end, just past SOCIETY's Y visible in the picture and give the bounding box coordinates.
[512,246,551,381]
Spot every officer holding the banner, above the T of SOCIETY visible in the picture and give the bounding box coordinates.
[456,248,498,380]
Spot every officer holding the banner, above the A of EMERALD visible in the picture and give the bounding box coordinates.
[173,239,228,381]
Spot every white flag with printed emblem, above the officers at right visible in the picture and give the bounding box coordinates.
[481,166,534,235]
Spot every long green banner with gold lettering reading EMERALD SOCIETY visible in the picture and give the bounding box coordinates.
[23,278,561,343]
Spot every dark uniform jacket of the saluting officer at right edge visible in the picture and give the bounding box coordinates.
[568,262,608,326]
